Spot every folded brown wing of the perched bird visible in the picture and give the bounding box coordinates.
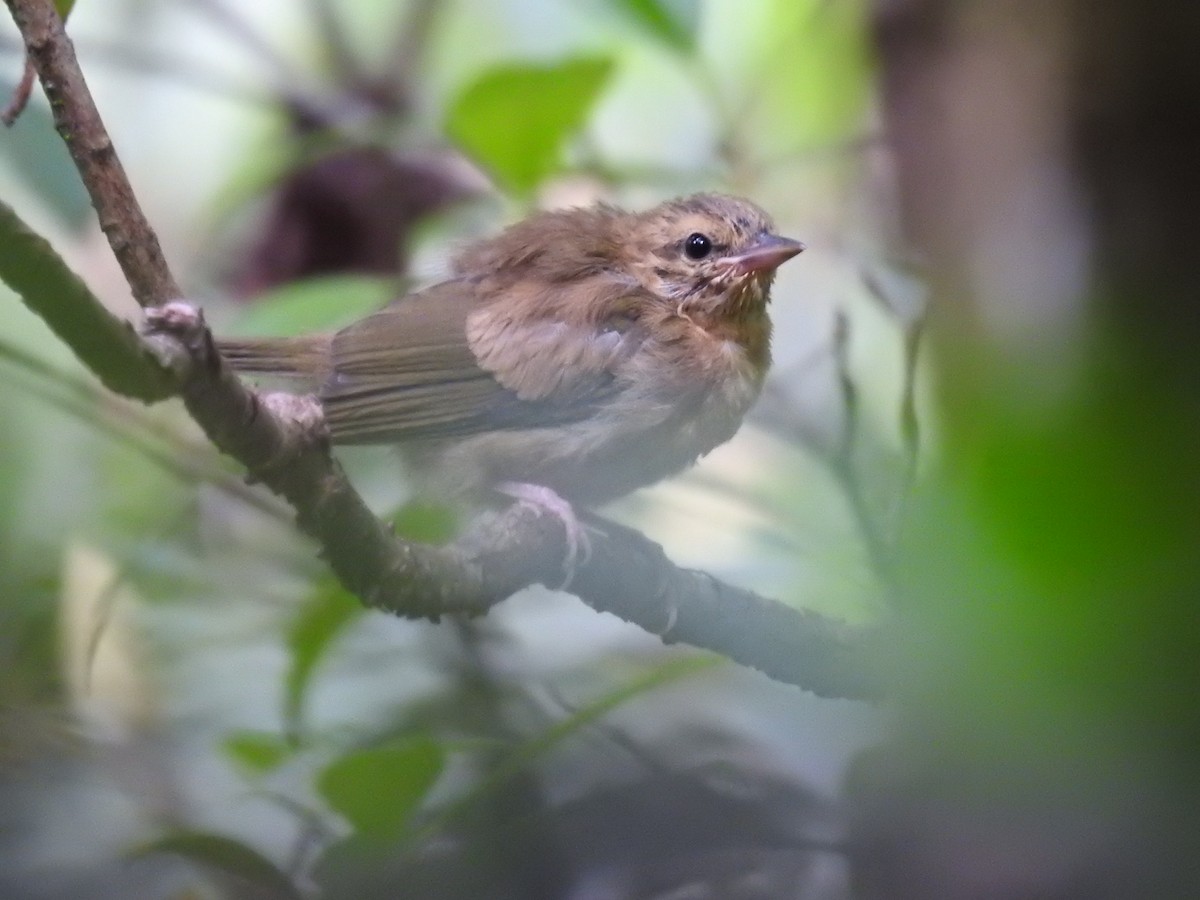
[320,281,635,444]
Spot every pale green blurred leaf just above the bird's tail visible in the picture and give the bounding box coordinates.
[234,275,400,337]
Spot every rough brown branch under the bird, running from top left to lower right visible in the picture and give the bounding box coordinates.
[0,0,882,697]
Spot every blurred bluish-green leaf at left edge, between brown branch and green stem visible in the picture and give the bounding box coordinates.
[0,84,91,232]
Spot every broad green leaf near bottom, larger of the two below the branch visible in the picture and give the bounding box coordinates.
[317,738,445,841]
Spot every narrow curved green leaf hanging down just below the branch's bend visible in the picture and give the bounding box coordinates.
[283,577,364,743]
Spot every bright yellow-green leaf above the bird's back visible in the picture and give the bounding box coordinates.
[446,58,613,192]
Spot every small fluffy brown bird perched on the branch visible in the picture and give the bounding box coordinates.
[220,194,804,561]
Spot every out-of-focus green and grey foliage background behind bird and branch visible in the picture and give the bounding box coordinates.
[0,0,1200,899]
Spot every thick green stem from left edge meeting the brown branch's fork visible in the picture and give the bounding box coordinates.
[0,202,173,401]
